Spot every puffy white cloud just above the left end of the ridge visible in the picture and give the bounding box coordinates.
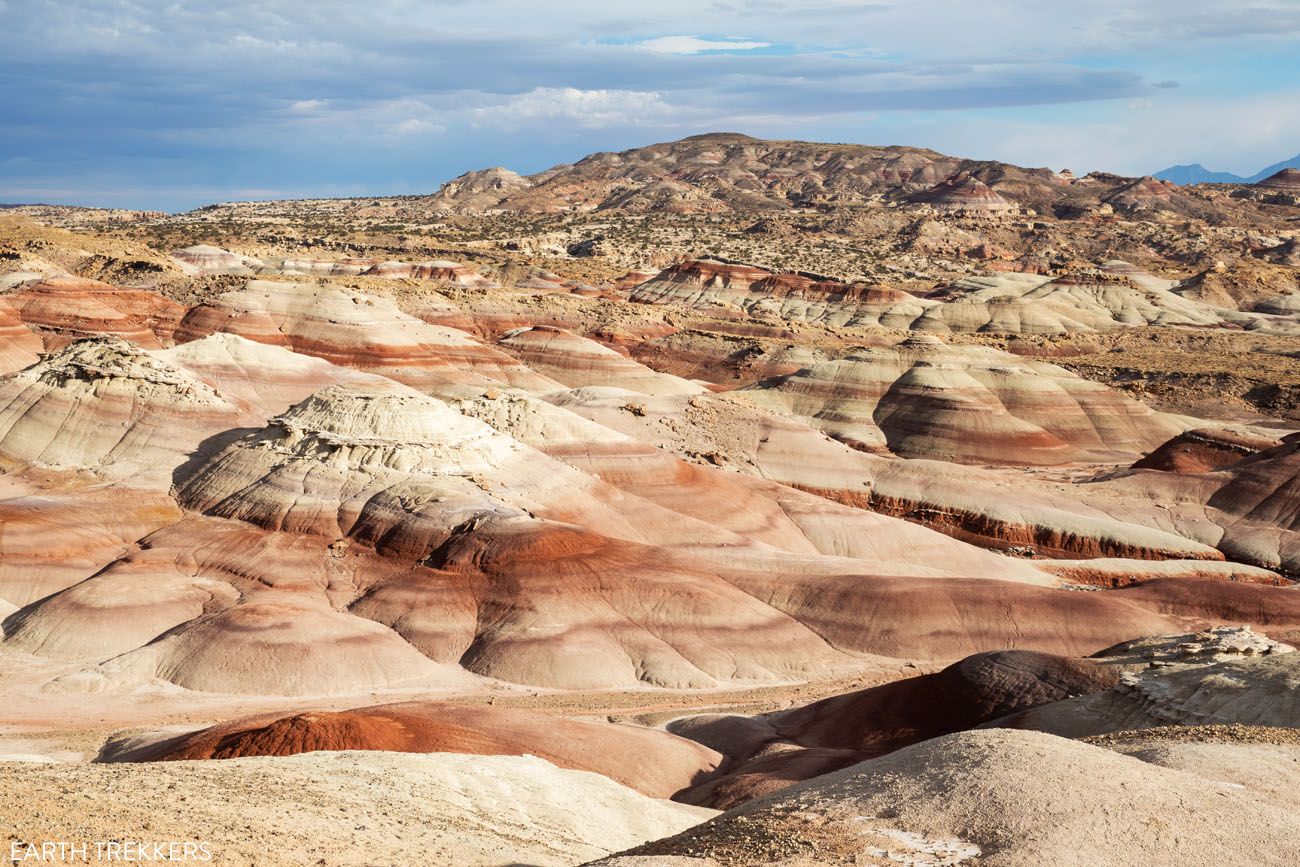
[471,87,673,129]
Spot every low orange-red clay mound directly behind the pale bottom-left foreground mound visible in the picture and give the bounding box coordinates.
[109,702,722,798]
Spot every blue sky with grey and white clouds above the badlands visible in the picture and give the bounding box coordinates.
[0,0,1300,211]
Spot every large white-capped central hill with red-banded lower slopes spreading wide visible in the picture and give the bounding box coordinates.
[0,343,1279,694]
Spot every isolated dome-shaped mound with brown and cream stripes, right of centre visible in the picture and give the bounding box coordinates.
[744,337,1186,464]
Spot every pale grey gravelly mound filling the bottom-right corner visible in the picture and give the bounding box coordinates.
[597,729,1300,867]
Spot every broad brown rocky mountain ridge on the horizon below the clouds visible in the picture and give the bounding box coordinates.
[429,133,1131,213]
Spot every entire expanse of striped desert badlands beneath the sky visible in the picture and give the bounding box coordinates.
[0,134,1300,867]
